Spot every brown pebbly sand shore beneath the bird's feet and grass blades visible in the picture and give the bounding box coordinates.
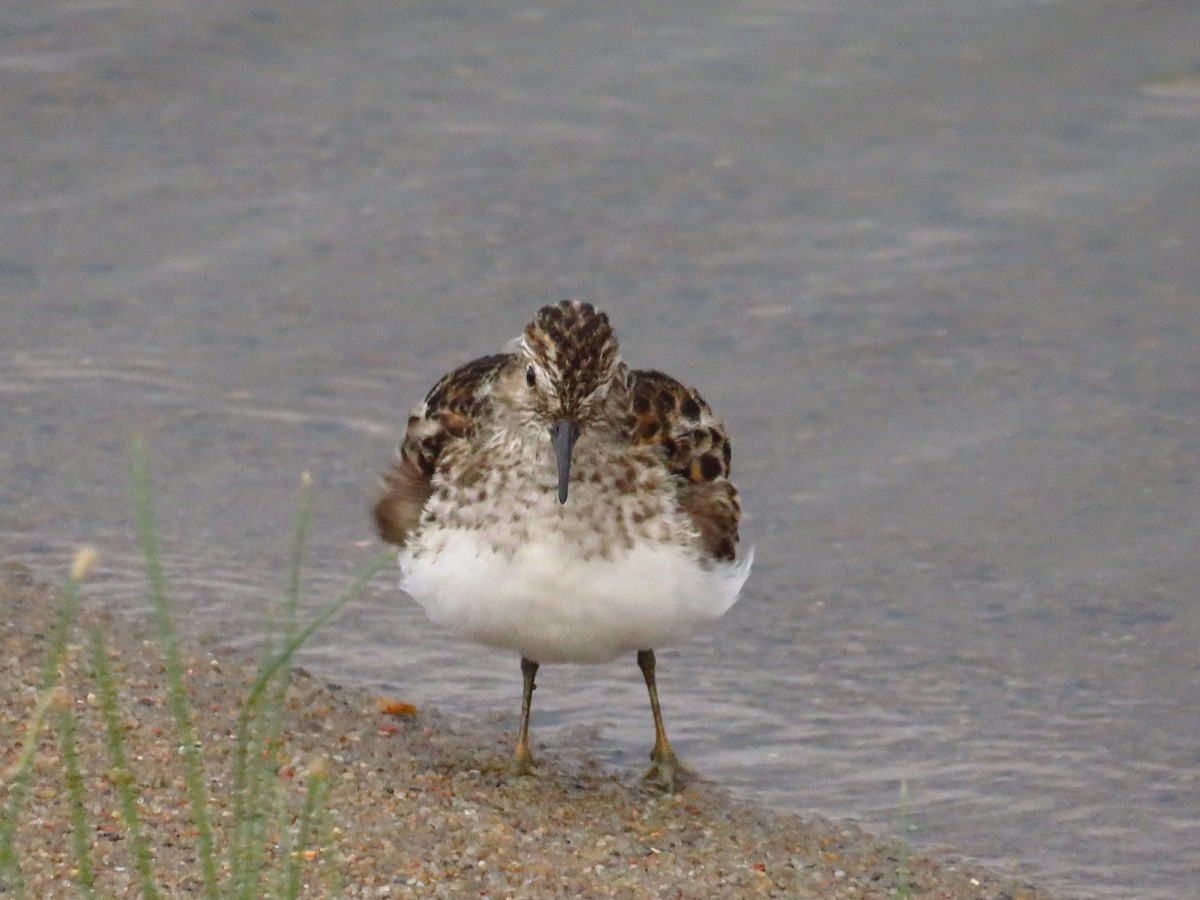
[0,564,1051,900]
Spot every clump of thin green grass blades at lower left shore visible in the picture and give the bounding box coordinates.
[7,438,395,900]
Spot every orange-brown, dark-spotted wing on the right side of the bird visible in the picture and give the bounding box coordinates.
[630,370,742,560]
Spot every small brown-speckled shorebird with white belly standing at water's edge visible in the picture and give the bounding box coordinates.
[374,300,752,790]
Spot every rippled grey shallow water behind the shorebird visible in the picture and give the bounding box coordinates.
[0,0,1200,898]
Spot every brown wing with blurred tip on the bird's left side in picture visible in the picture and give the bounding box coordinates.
[373,354,511,546]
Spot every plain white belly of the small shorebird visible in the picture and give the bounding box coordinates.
[400,528,754,662]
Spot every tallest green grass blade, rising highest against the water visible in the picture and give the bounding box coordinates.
[132,438,221,900]
